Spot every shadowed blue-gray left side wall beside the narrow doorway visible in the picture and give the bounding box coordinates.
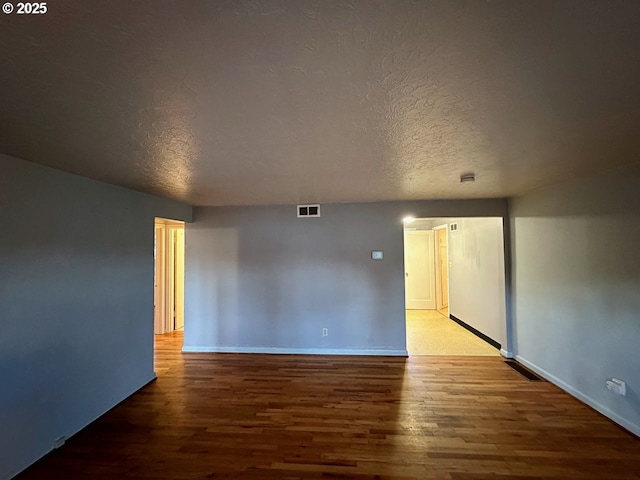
[0,155,191,479]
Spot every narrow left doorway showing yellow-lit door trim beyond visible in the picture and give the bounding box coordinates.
[153,218,185,335]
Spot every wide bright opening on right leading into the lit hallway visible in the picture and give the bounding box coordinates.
[404,217,506,356]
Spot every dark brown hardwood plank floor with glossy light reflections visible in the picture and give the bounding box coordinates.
[17,334,640,480]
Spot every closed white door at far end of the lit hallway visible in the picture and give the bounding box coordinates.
[404,230,436,310]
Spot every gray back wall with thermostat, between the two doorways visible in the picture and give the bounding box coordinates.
[185,199,506,354]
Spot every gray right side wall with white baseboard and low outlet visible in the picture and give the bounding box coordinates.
[510,165,640,435]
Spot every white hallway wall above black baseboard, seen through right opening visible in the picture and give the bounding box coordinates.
[448,218,507,348]
